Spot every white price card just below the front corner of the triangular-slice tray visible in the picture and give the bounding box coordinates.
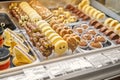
[23,66,49,80]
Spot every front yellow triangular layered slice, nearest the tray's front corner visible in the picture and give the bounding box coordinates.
[12,45,35,66]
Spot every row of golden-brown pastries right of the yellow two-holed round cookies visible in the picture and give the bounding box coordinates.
[49,20,80,52]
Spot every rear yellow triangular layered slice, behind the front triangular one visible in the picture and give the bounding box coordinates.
[3,28,29,56]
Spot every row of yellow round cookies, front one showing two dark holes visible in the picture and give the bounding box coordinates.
[36,20,68,55]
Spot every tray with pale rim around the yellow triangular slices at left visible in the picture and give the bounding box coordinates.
[0,6,40,73]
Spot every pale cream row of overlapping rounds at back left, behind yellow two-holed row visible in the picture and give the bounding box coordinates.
[19,2,42,22]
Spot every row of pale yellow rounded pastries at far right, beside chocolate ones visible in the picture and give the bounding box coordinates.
[78,0,120,42]
